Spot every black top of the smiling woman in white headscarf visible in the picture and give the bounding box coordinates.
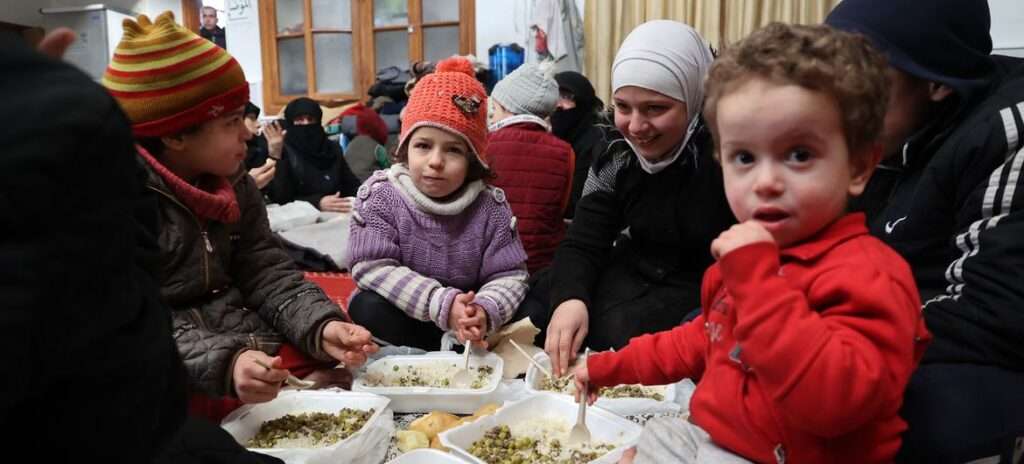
[550,122,735,349]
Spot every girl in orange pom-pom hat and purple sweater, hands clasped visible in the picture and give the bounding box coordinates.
[348,57,527,349]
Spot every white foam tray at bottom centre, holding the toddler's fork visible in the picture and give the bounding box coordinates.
[440,393,643,464]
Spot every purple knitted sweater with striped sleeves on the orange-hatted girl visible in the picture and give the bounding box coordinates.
[348,165,528,331]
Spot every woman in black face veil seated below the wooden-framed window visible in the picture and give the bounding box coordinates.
[268,97,360,213]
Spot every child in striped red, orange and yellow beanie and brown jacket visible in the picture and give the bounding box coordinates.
[102,12,376,420]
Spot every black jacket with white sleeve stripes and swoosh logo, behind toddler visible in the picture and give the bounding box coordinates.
[858,56,1024,370]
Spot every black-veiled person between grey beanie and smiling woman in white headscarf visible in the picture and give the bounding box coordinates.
[551,71,610,219]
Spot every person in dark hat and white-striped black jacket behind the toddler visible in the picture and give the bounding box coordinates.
[825,0,1024,462]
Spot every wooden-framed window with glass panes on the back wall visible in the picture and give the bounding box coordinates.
[259,0,476,114]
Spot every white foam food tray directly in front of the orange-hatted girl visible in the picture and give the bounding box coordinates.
[352,351,504,414]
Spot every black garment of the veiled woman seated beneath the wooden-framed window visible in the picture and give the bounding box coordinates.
[267,140,361,209]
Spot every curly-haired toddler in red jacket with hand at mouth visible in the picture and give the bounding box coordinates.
[575,24,930,463]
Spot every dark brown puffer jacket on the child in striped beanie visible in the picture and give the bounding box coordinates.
[143,162,345,396]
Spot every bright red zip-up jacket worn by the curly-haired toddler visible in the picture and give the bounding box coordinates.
[587,214,931,463]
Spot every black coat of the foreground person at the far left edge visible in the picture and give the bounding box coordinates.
[0,34,185,462]
